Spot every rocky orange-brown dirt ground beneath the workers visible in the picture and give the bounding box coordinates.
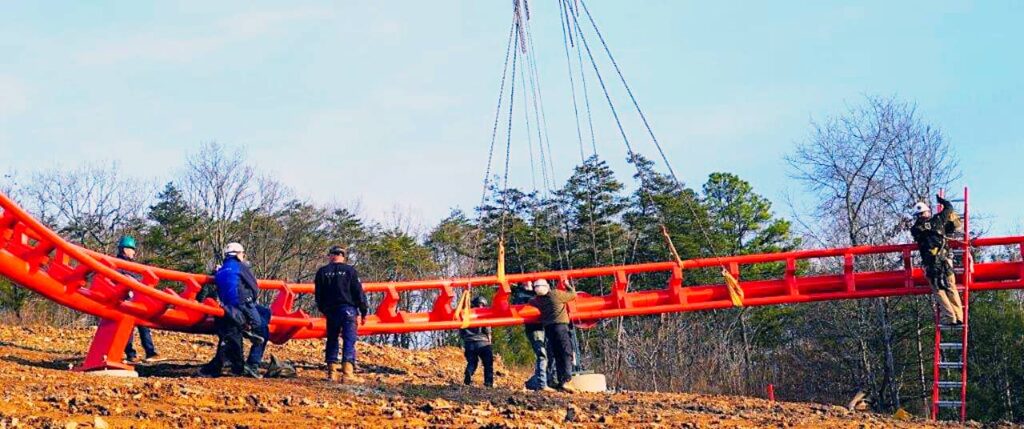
[0,326,1003,428]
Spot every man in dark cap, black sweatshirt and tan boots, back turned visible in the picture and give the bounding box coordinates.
[313,246,369,383]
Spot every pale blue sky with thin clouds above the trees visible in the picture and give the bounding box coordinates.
[0,0,1024,233]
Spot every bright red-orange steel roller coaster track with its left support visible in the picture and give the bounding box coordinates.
[0,189,1024,371]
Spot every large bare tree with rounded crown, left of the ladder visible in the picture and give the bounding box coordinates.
[786,96,958,410]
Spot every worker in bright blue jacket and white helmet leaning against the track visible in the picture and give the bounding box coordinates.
[200,243,270,379]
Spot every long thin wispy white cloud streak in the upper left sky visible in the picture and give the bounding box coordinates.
[76,7,333,66]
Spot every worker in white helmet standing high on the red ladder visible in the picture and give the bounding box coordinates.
[910,196,964,325]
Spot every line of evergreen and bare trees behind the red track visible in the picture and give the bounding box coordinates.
[0,96,1024,422]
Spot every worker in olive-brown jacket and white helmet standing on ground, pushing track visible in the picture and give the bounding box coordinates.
[529,278,578,393]
